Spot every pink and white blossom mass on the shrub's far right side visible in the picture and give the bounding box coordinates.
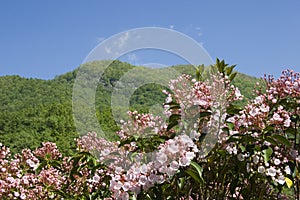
[226,70,300,188]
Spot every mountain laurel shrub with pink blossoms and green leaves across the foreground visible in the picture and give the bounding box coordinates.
[0,60,300,199]
